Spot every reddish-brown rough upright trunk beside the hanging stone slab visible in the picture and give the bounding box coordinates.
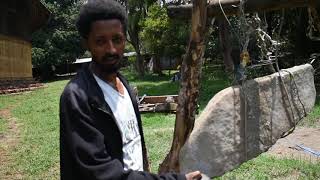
[159,0,207,173]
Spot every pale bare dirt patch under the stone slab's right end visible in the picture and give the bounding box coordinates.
[267,127,320,163]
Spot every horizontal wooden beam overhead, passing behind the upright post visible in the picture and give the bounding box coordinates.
[168,0,320,19]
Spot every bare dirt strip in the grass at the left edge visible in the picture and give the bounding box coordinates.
[0,107,22,180]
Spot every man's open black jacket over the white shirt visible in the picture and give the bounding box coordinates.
[60,65,185,180]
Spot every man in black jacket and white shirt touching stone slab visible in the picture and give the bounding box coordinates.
[60,0,201,180]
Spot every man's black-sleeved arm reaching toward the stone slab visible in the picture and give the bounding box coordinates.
[60,88,186,180]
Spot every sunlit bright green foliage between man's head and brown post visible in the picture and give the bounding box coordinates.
[140,4,190,57]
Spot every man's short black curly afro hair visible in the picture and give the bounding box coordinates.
[76,0,128,39]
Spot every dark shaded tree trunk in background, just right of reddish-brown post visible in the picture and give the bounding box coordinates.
[219,18,234,73]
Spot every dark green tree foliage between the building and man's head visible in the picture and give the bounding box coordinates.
[32,0,84,78]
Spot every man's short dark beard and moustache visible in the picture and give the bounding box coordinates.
[92,54,122,74]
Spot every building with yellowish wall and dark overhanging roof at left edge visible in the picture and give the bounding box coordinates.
[0,0,50,81]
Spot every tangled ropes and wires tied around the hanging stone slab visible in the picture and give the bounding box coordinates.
[219,0,306,156]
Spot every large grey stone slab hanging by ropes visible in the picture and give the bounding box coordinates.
[180,64,316,177]
